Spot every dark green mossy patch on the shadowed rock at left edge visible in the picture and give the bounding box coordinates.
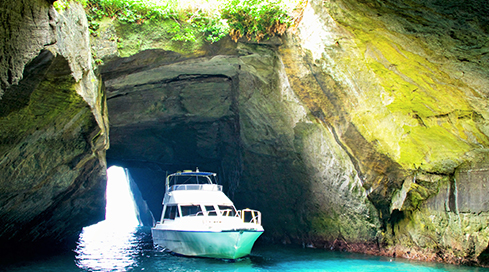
[0,56,94,154]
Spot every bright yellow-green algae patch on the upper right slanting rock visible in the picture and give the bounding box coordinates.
[324,2,489,173]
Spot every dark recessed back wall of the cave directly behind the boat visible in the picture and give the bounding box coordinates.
[101,50,242,223]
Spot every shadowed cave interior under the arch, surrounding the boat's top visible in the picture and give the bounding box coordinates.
[96,43,340,242]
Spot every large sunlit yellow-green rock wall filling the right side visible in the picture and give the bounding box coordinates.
[279,1,489,263]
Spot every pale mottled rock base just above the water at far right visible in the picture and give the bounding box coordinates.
[385,206,489,263]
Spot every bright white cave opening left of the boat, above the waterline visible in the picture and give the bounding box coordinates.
[105,166,139,226]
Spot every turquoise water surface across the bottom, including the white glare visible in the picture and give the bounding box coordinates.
[0,221,489,272]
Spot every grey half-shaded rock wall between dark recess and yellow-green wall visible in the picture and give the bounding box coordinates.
[235,43,379,244]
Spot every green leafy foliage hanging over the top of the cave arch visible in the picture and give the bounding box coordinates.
[81,0,293,43]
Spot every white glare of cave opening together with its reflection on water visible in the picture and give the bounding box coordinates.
[75,167,144,271]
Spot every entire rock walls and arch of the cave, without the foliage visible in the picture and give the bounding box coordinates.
[0,0,489,261]
